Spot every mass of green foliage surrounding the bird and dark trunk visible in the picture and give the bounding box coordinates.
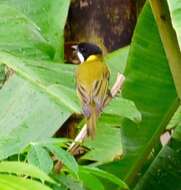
[0,0,181,190]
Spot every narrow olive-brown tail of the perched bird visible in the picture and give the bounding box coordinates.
[87,111,97,139]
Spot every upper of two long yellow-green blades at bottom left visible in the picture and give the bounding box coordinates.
[0,161,55,183]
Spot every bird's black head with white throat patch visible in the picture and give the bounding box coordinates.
[74,42,102,62]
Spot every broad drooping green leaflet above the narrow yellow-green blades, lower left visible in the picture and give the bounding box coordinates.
[27,145,53,173]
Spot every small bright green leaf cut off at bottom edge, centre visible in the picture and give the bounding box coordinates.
[79,171,104,190]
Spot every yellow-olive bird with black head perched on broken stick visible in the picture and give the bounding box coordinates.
[72,42,110,139]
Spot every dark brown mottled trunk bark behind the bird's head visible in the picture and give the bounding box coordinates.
[65,0,136,53]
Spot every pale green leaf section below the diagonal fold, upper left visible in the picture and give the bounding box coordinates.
[0,4,54,59]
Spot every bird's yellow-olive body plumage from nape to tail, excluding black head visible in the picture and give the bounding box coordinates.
[76,50,110,138]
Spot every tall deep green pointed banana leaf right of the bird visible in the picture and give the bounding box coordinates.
[102,3,178,187]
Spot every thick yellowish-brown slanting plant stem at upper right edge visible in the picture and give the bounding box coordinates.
[149,0,181,99]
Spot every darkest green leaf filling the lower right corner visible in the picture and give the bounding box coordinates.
[135,119,181,190]
